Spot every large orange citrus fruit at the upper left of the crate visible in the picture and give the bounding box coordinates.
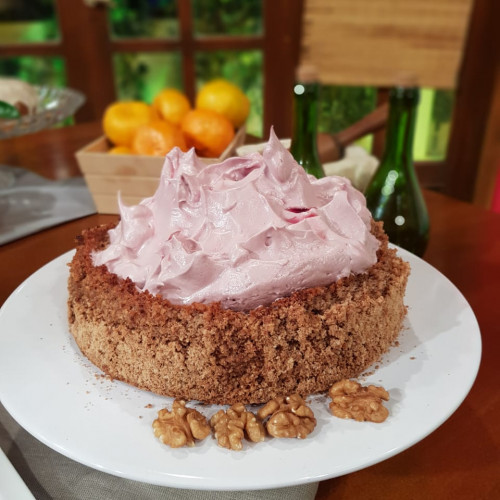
[102,101,154,146]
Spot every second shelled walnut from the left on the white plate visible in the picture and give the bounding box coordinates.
[210,403,266,451]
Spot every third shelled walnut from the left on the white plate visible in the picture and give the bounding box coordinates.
[257,394,316,439]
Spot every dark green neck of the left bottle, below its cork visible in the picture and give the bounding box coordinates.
[292,83,319,156]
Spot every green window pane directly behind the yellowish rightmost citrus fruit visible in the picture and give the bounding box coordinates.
[195,50,269,137]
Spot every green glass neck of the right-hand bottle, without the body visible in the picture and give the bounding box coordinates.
[382,87,419,168]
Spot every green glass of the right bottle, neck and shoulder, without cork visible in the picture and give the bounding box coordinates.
[365,87,429,256]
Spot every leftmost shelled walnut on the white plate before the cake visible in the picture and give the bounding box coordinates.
[153,399,210,448]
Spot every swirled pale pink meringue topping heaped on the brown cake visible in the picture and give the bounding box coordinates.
[93,131,379,310]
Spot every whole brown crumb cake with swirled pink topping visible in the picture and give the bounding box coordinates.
[68,133,410,404]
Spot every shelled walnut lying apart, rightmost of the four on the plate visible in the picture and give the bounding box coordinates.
[328,380,389,423]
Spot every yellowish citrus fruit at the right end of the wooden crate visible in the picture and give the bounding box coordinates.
[196,78,250,128]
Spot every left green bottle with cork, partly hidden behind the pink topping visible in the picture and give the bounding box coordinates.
[290,66,325,179]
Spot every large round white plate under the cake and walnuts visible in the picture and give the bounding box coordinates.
[0,250,481,490]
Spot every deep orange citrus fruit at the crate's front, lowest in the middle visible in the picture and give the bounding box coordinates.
[132,120,187,156]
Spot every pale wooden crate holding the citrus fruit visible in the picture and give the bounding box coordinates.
[76,126,246,214]
